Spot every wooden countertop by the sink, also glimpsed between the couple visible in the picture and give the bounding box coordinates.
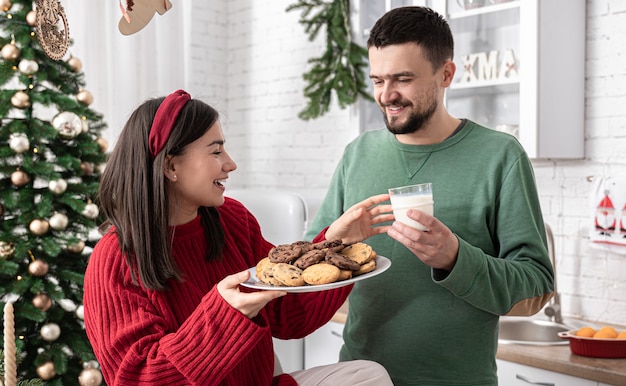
[331,302,626,385]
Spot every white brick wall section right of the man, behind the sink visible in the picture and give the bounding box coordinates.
[535,0,626,325]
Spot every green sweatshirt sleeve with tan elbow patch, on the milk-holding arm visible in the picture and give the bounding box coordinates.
[433,152,554,316]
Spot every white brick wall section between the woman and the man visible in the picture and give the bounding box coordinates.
[223,0,358,190]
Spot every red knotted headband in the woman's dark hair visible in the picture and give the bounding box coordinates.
[148,90,191,158]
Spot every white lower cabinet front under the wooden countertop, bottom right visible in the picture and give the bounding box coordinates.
[497,360,598,386]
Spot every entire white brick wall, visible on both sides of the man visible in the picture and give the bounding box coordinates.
[224,0,626,325]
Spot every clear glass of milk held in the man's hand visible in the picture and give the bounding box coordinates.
[389,182,435,231]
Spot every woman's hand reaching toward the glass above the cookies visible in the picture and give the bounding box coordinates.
[326,194,394,244]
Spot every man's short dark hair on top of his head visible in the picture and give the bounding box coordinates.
[367,6,454,70]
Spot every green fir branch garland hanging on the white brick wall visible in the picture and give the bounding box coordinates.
[287,0,373,120]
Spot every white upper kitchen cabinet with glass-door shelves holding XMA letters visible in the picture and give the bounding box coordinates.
[434,0,585,159]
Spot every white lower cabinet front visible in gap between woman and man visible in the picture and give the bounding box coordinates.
[304,321,344,369]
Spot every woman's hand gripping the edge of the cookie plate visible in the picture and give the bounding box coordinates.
[217,271,287,319]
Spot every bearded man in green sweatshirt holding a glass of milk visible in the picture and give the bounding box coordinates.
[307,7,554,386]
